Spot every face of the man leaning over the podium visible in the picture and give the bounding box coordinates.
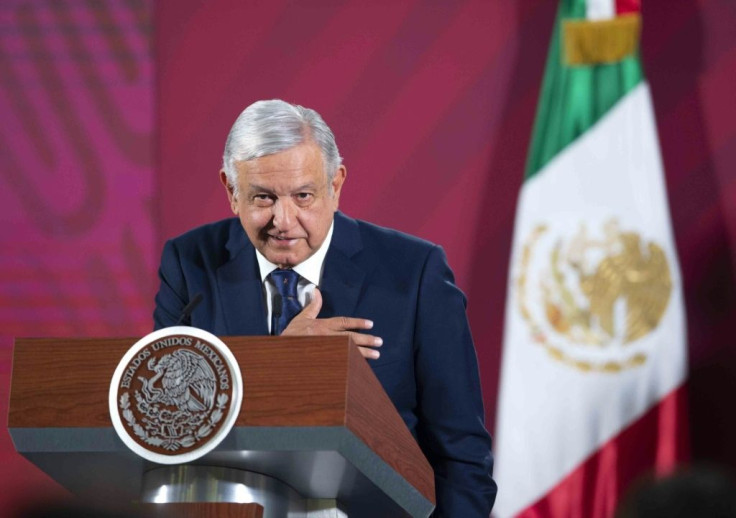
[220,143,346,268]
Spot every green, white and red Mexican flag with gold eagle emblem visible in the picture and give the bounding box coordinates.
[494,0,687,518]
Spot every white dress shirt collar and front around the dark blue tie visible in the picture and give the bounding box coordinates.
[256,221,335,333]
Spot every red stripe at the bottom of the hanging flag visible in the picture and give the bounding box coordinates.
[512,385,689,518]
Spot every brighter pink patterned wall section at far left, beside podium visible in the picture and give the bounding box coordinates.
[0,0,159,516]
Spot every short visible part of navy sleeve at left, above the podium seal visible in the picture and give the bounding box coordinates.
[153,241,188,330]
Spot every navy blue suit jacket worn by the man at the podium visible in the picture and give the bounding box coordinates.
[154,212,496,518]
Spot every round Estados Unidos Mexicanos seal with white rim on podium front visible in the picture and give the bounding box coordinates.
[109,326,243,464]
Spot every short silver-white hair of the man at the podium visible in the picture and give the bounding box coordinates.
[222,99,342,196]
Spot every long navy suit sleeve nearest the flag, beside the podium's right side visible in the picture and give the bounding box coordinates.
[414,246,496,518]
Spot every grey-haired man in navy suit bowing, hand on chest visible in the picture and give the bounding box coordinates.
[154,100,496,518]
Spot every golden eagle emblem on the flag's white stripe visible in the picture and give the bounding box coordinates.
[514,220,673,372]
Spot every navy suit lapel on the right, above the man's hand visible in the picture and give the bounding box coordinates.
[319,212,366,318]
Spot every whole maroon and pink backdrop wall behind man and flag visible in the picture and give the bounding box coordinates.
[0,0,736,514]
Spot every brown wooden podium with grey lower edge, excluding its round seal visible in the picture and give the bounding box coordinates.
[8,337,434,518]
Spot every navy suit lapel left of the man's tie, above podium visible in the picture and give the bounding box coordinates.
[217,221,268,335]
